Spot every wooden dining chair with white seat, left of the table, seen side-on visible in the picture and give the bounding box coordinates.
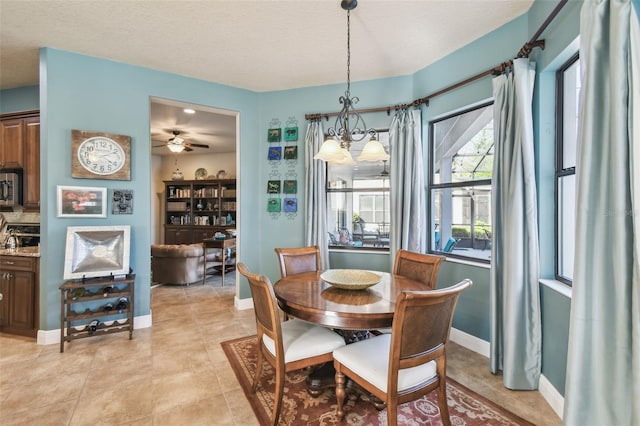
[237,262,345,425]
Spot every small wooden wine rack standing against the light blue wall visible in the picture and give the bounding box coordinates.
[60,274,135,352]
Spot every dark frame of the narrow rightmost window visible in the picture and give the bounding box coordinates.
[553,52,580,286]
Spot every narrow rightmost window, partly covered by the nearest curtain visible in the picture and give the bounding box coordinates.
[555,54,580,284]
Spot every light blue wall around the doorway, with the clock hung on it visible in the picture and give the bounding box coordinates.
[40,48,262,330]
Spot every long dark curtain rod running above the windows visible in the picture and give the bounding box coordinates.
[304,0,569,120]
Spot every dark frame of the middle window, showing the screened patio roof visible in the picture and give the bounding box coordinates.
[427,98,495,265]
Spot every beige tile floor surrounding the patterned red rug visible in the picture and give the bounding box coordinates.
[0,275,561,426]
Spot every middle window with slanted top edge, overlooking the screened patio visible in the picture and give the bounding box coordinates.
[429,103,494,262]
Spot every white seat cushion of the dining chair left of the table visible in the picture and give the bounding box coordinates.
[262,319,345,363]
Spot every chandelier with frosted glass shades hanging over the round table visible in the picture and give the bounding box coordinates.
[313,0,389,165]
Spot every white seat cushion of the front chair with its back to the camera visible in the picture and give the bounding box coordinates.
[333,334,436,392]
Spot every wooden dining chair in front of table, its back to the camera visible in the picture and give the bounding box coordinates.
[333,279,472,426]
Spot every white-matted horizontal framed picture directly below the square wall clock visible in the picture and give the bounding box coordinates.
[56,185,107,217]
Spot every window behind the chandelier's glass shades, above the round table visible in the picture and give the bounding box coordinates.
[327,130,390,250]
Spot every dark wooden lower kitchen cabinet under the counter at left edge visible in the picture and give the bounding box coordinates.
[0,256,40,338]
